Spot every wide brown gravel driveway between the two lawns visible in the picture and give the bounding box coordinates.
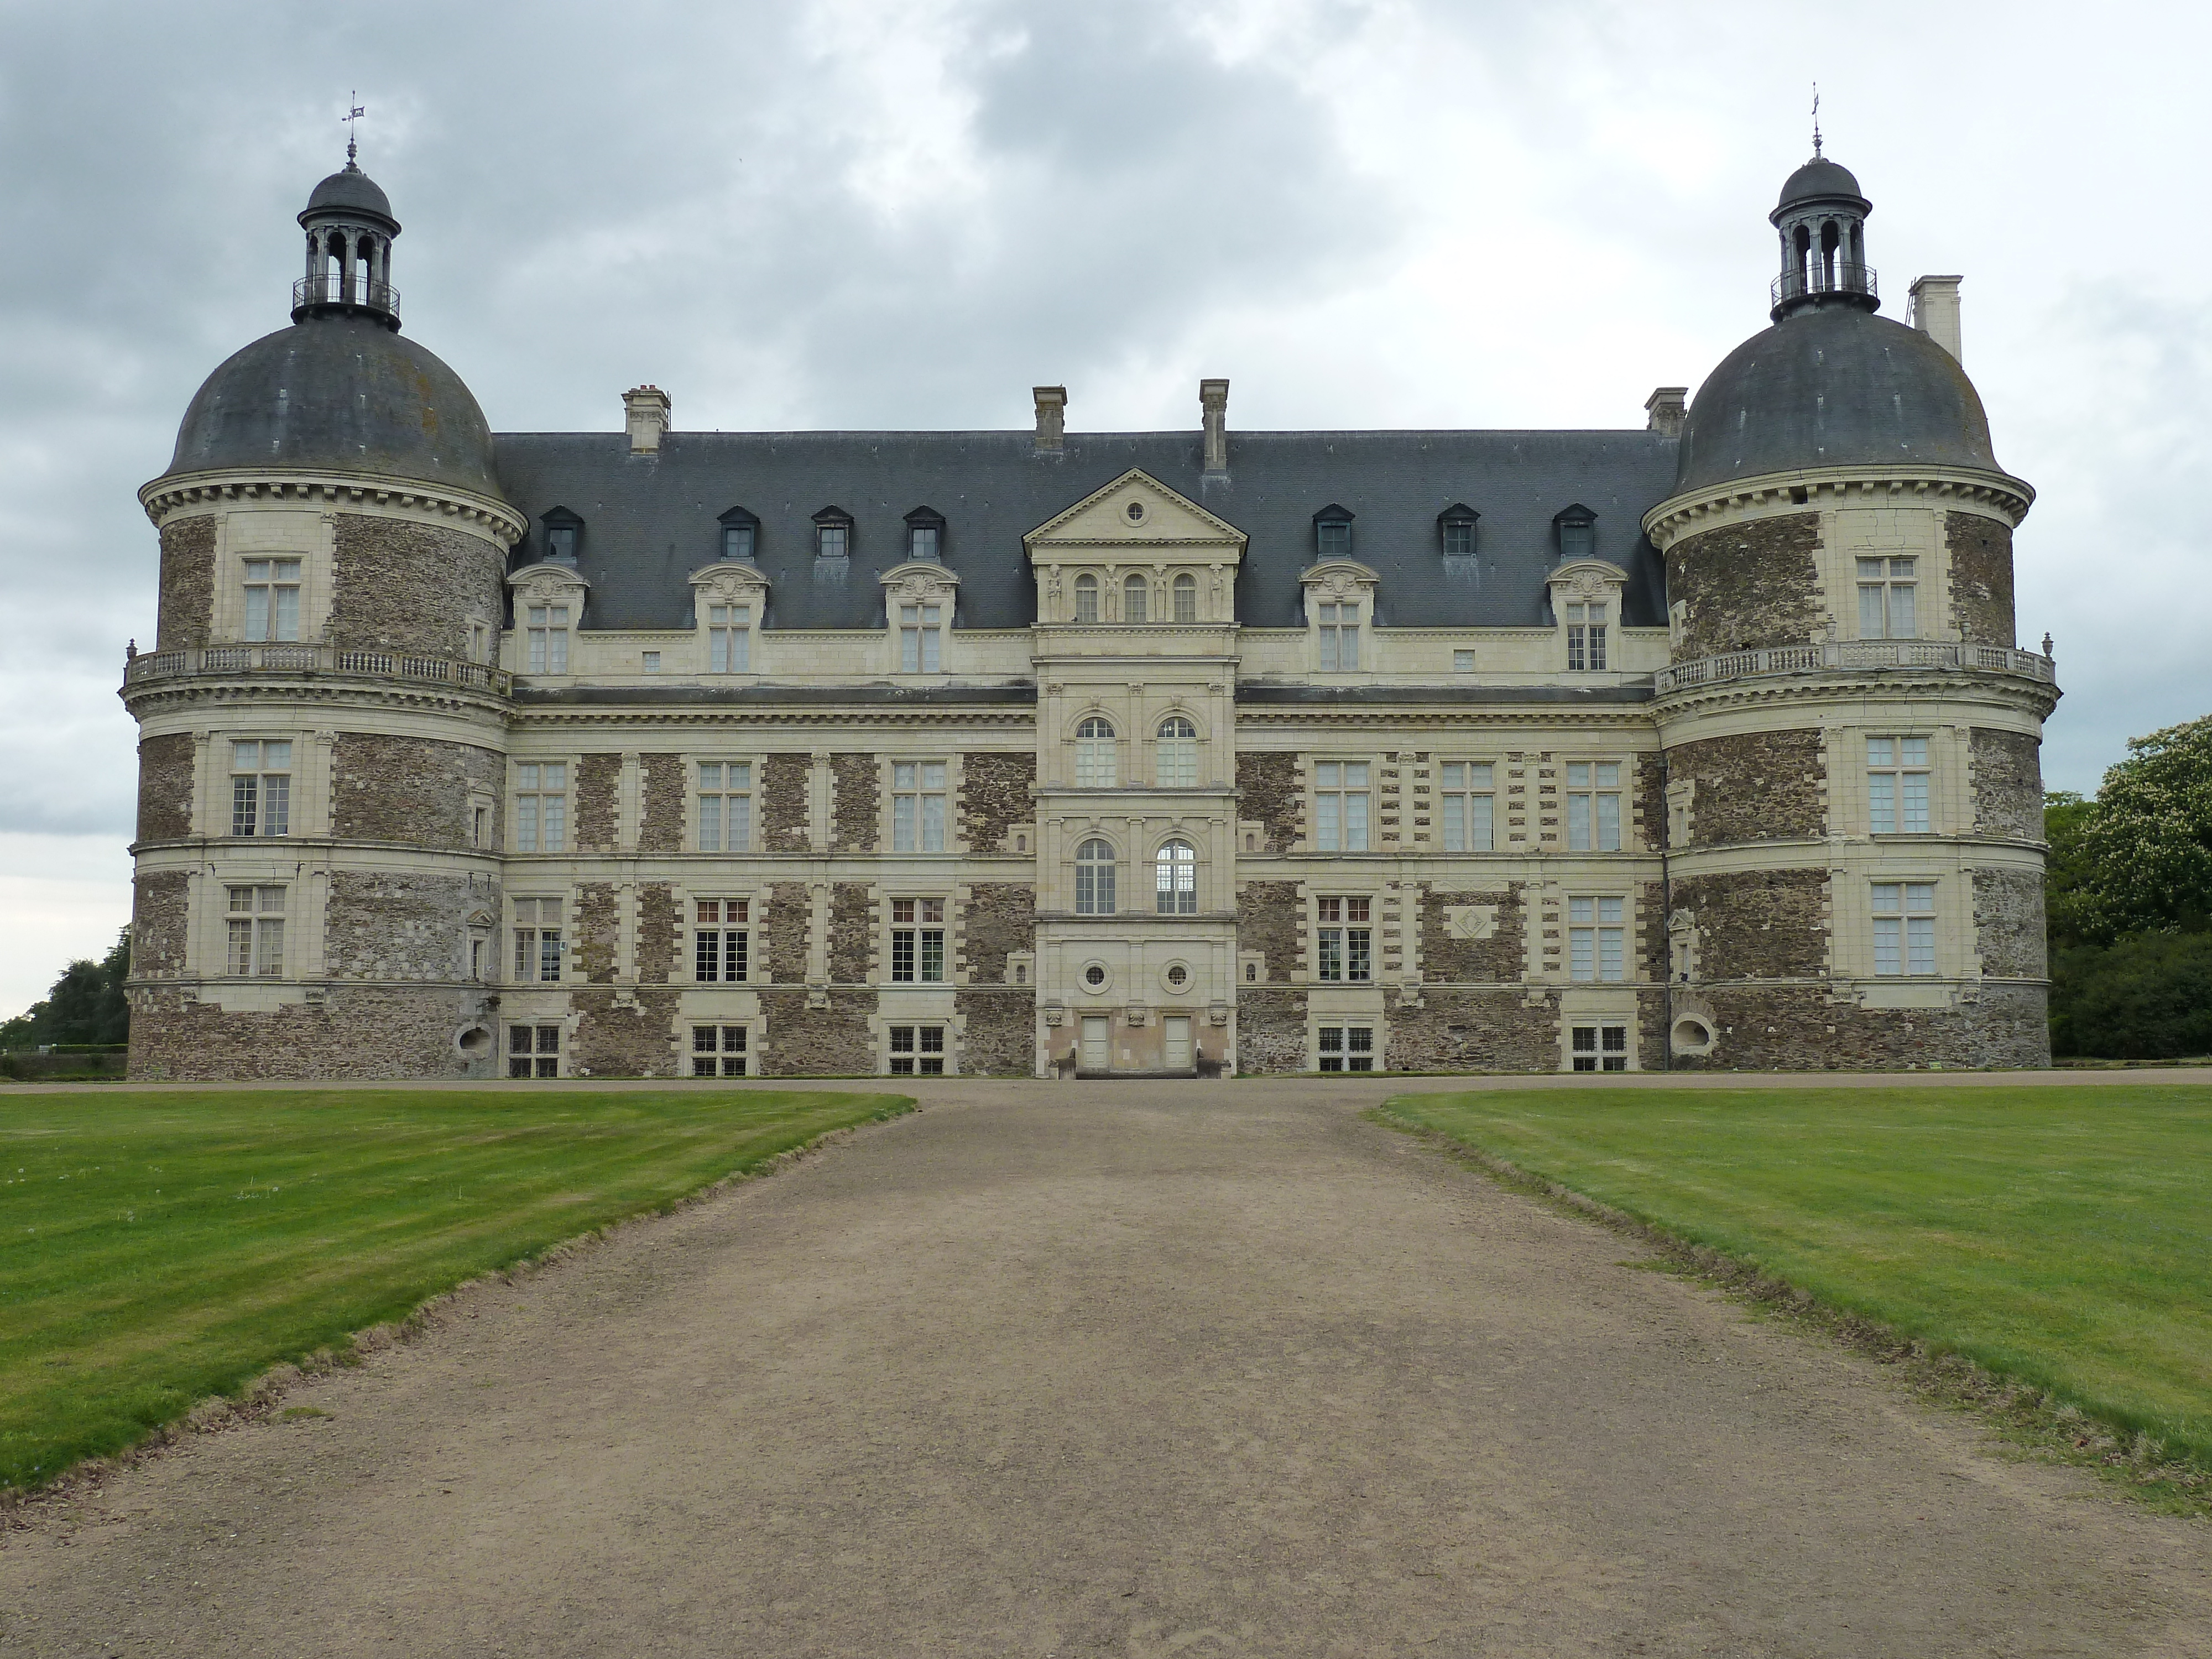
[0,1082,2212,1659]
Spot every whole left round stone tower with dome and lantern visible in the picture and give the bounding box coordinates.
[122,146,524,1077]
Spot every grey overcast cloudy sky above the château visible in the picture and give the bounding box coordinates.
[0,0,2212,1015]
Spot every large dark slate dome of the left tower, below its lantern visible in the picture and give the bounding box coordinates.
[164,316,500,500]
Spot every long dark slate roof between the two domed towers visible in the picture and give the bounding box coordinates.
[493,431,1677,628]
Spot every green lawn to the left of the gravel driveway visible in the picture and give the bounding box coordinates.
[0,1088,911,1486]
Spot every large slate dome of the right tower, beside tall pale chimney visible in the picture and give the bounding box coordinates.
[1674,305,2004,495]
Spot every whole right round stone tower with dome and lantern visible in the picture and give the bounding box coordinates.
[1644,155,2059,1071]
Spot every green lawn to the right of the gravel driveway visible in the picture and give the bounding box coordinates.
[1383,1084,2212,1467]
